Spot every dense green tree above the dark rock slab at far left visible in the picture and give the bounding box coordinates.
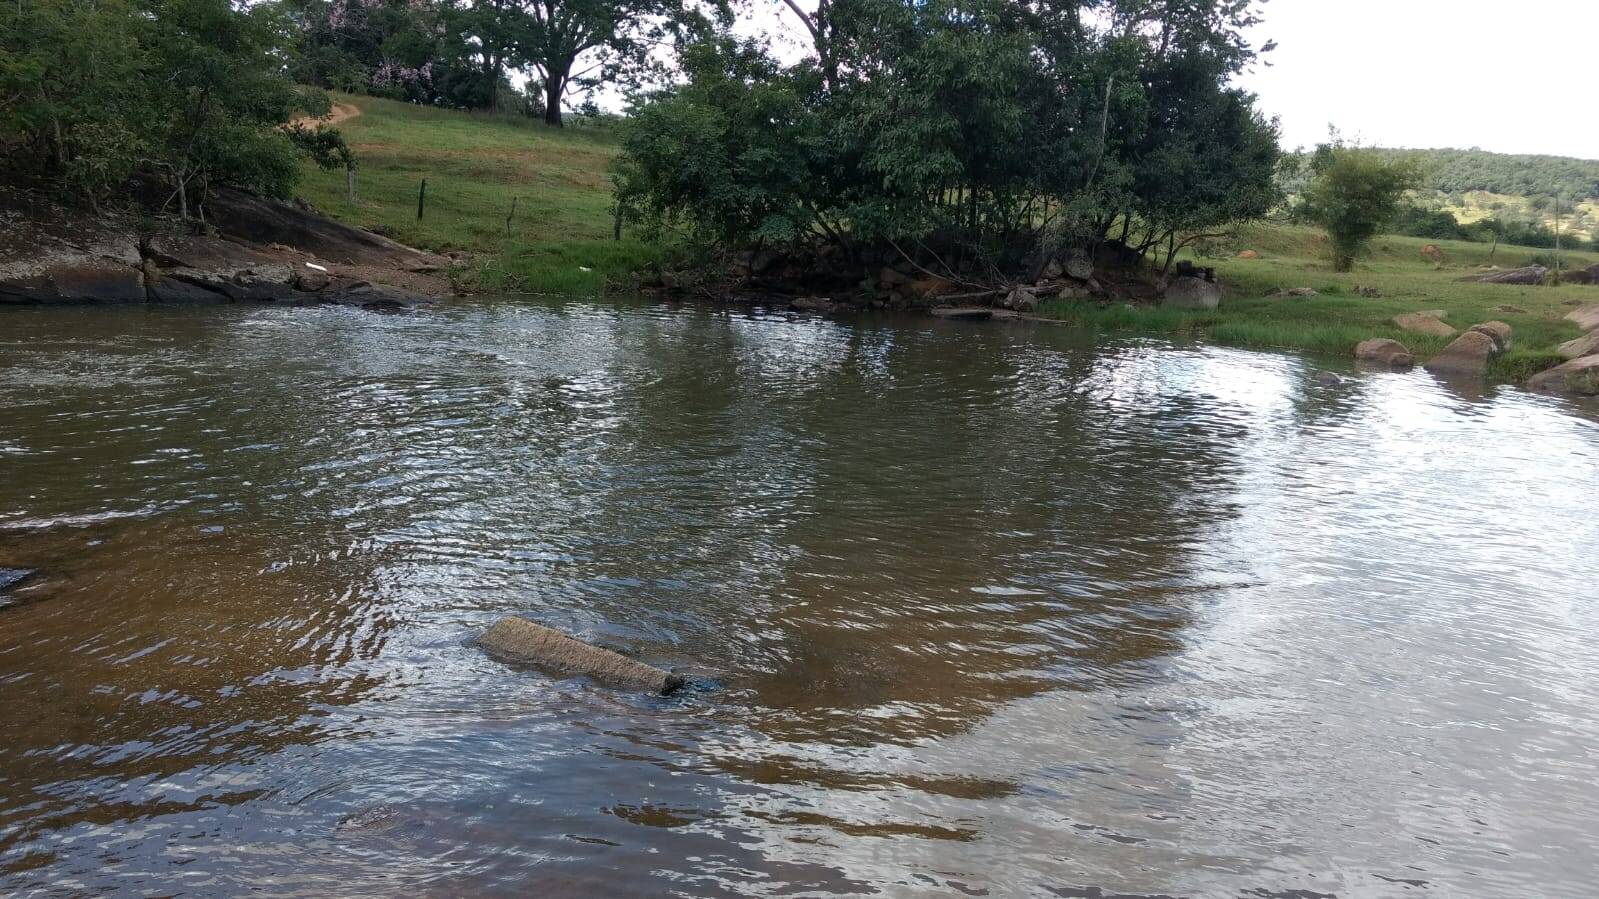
[0,0,326,206]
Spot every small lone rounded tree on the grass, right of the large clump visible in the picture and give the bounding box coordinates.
[1305,142,1422,272]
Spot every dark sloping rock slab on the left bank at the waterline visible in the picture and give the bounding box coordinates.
[0,189,448,307]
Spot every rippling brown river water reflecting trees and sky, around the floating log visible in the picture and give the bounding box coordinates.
[0,302,1599,896]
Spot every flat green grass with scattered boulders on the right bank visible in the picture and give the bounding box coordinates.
[1043,224,1599,379]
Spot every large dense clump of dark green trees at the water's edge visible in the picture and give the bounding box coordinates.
[604,0,1278,274]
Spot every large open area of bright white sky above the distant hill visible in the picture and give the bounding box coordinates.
[1241,0,1599,158]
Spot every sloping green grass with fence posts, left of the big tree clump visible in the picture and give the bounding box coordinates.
[297,94,657,293]
